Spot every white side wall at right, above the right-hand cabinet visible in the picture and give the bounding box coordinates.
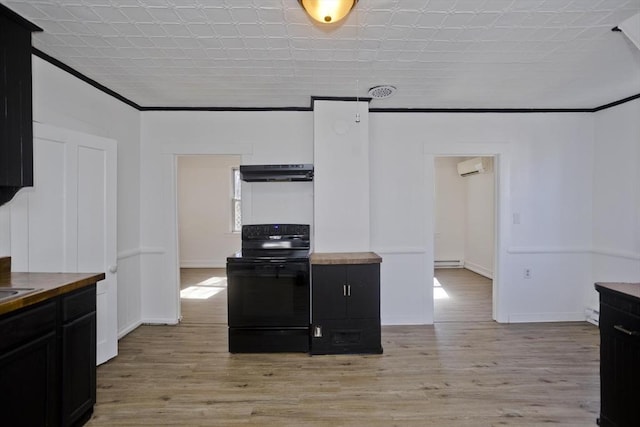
[586,100,640,308]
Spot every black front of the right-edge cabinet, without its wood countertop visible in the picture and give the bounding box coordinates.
[600,304,640,426]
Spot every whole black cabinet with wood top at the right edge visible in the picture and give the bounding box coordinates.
[596,283,640,427]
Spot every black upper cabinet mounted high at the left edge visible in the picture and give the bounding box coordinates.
[0,4,42,205]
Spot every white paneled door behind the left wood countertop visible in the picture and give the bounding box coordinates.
[11,123,118,364]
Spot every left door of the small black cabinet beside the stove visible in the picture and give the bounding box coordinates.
[311,265,347,321]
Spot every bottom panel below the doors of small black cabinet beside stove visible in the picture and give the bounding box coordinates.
[311,319,382,355]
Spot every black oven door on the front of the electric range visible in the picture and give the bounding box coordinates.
[227,261,309,328]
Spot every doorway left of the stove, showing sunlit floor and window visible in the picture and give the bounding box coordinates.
[177,154,241,325]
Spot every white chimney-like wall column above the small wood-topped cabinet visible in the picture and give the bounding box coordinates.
[313,101,371,252]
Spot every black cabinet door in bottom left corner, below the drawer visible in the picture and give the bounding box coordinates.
[0,330,59,427]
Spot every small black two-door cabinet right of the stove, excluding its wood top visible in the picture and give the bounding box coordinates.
[311,263,382,354]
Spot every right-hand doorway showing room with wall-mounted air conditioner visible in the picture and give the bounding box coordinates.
[433,156,496,322]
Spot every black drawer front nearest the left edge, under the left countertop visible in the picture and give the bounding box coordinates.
[0,301,56,351]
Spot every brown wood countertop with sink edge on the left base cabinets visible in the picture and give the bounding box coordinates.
[0,258,105,315]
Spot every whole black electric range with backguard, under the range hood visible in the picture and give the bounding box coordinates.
[227,224,310,353]
